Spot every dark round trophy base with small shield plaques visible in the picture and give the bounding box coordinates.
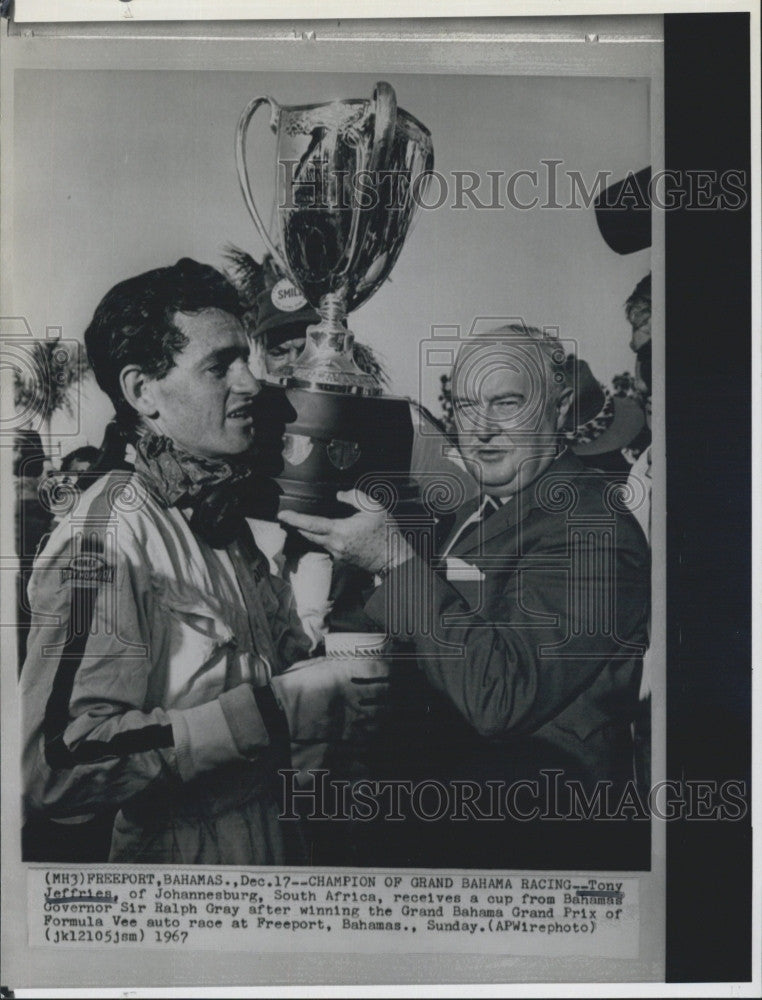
[267,386,419,517]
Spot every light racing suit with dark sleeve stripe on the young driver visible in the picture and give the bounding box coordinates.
[21,472,310,864]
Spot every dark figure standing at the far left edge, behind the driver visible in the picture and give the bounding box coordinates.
[13,430,53,670]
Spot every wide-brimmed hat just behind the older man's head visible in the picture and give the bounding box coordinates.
[562,354,646,456]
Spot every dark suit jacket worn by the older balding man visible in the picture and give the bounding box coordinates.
[366,452,650,816]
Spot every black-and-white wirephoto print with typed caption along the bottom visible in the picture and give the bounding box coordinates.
[0,7,751,995]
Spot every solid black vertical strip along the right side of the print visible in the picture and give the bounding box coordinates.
[664,13,758,982]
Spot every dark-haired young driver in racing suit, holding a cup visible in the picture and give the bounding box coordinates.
[21,259,386,865]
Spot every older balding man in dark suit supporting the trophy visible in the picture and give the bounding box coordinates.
[282,325,649,868]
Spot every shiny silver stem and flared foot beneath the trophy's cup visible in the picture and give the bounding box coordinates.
[284,292,381,396]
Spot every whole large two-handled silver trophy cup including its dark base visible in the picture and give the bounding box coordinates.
[236,82,434,516]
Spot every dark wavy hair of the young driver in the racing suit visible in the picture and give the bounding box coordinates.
[85,257,242,433]
